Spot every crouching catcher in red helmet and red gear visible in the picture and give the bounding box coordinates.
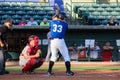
[19,35,43,73]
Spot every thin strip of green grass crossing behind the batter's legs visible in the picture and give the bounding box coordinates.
[6,66,120,71]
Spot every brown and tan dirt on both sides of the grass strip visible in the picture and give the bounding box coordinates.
[0,62,120,80]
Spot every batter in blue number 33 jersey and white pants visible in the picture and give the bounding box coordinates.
[48,13,74,76]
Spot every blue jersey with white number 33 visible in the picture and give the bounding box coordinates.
[50,20,68,38]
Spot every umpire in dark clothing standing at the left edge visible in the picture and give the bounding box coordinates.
[0,18,12,75]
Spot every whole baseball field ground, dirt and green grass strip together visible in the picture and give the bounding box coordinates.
[0,62,120,80]
